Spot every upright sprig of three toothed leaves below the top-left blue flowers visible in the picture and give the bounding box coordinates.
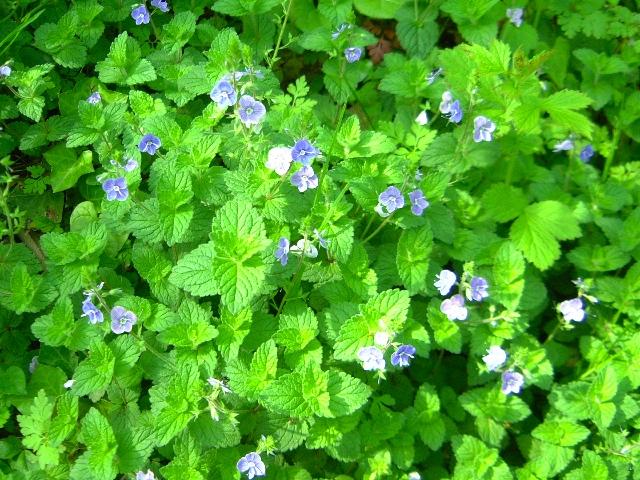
[96,32,156,85]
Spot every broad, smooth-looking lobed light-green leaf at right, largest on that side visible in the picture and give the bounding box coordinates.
[510,200,581,270]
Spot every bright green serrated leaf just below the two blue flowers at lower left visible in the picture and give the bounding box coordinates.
[71,342,115,396]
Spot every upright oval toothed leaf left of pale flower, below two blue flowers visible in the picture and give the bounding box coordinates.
[396,225,433,295]
